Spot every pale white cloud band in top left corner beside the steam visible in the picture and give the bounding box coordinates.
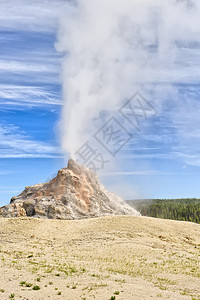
[0,0,69,31]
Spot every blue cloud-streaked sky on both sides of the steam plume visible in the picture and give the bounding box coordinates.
[0,0,200,205]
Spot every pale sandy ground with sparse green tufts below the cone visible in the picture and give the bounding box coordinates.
[0,216,200,300]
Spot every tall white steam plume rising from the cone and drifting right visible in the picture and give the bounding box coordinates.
[56,0,200,156]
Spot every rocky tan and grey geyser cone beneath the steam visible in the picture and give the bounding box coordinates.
[0,160,140,220]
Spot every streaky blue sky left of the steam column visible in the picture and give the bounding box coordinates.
[0,1,65,205]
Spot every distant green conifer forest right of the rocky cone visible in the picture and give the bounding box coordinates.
[127,198,200,223]
